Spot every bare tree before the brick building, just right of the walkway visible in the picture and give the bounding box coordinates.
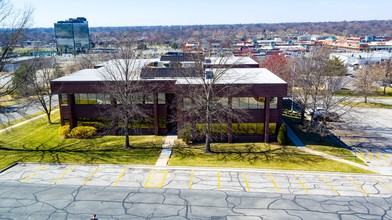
[177,56,251,153]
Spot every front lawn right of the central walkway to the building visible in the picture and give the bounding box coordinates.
[169,143,370,173]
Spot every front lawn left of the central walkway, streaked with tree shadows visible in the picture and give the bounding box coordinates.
[0,112,162,169]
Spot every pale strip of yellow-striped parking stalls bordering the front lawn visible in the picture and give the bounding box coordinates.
[0,164,392,197]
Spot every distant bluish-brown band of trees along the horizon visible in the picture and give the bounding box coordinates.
[21,20,392,45]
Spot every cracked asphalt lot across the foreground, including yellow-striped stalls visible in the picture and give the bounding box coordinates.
[0,164,392,219]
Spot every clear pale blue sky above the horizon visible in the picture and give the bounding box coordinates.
[11,0,392,27]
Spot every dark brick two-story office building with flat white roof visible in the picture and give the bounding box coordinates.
[51,53,287,142]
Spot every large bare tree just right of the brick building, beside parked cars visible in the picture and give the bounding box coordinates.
[294,48,347,133]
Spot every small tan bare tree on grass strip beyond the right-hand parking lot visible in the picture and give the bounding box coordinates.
[354,64,382,103]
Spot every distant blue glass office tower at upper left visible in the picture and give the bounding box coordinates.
[54,17,90,53]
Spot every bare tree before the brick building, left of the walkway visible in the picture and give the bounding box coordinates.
[101,41,153,149]
